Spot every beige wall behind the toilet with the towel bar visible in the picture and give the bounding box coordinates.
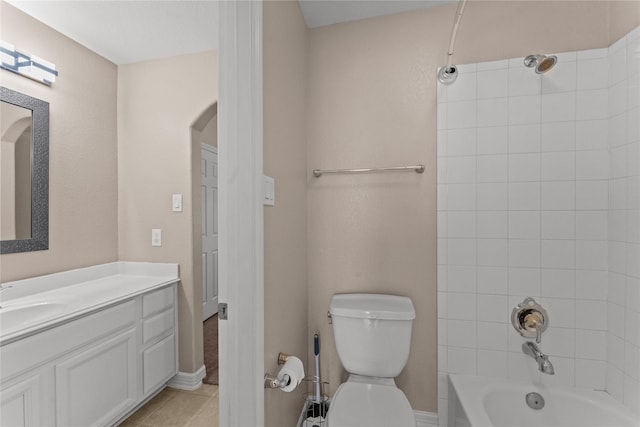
[307,9,440,411]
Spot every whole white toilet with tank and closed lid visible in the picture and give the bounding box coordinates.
[327,294,416,427]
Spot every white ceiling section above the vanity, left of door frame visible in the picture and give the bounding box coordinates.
[6,0,218,64]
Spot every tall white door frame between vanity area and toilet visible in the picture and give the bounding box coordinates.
[218,0,264,427]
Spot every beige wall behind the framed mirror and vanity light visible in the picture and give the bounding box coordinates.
[0,2,118,282]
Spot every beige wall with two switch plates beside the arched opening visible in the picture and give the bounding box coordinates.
[118,51,218,372]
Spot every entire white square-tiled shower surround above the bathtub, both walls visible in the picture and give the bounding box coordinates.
[438,25,640,425]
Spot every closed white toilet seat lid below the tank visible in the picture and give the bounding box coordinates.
[327,381,416,427]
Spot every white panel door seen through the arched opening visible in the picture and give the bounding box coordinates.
[201,144,218,320]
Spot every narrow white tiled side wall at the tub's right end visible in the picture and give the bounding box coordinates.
[606,29,640,412]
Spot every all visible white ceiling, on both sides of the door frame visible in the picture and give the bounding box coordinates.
[6,0,457,65]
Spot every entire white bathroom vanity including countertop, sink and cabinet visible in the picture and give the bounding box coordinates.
[0,262,179,427]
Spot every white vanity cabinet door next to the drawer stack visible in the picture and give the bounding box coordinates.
[55,329,137,427]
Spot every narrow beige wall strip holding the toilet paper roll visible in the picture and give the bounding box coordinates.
[264,1,313,427]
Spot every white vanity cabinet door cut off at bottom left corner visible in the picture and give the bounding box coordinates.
[0,374,43,427]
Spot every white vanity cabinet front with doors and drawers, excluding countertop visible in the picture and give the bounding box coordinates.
[0,276,178,427]
